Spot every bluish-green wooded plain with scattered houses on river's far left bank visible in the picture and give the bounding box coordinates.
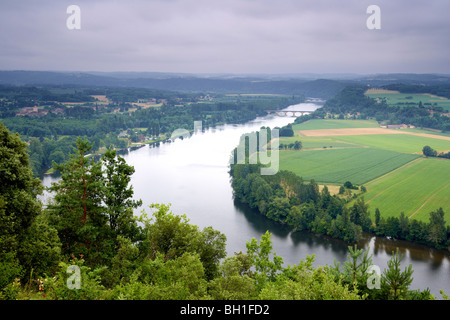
[0,86,303,176]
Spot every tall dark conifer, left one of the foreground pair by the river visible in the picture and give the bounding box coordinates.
[48,138,105,262]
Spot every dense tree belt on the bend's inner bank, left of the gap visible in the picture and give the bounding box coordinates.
[230,164,364,243]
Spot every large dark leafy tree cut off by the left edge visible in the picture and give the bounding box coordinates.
[0,123,43,286]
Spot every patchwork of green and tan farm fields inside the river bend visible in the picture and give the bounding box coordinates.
[280,120,450,222]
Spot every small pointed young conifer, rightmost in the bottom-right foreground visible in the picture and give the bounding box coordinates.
[381,248,414,300]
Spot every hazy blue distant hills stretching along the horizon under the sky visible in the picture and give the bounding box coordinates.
[0,70,450,99]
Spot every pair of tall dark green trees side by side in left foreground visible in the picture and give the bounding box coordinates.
[48,138,143,264]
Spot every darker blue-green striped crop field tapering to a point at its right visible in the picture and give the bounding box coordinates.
[280,148,419,185]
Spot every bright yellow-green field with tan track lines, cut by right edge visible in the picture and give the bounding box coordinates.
[364,158,450,222]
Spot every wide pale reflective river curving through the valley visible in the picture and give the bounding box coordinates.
[39,103,450,298]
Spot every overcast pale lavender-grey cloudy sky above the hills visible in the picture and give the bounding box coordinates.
[0,0,450,74]
